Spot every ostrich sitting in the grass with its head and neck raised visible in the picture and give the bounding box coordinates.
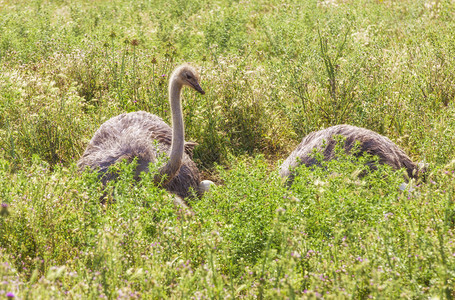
[78,64,211,204]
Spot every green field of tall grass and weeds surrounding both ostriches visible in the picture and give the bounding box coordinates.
[0,0,455,299]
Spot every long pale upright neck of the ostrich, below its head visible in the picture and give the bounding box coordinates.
[155,76,185,183]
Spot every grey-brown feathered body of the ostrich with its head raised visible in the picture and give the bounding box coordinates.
[78,111,200,198]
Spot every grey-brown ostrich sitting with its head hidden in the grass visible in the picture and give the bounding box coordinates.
[280,125,418,183]
